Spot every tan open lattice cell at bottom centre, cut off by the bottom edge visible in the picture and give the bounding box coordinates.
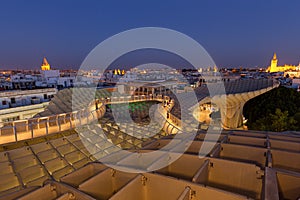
[111,173,246,200]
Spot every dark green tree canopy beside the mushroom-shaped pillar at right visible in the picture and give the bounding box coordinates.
[243,87,300,131]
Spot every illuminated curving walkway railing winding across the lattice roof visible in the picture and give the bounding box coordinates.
[0,91,181,144]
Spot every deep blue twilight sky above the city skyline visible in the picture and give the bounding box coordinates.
[0,0,300,69]
